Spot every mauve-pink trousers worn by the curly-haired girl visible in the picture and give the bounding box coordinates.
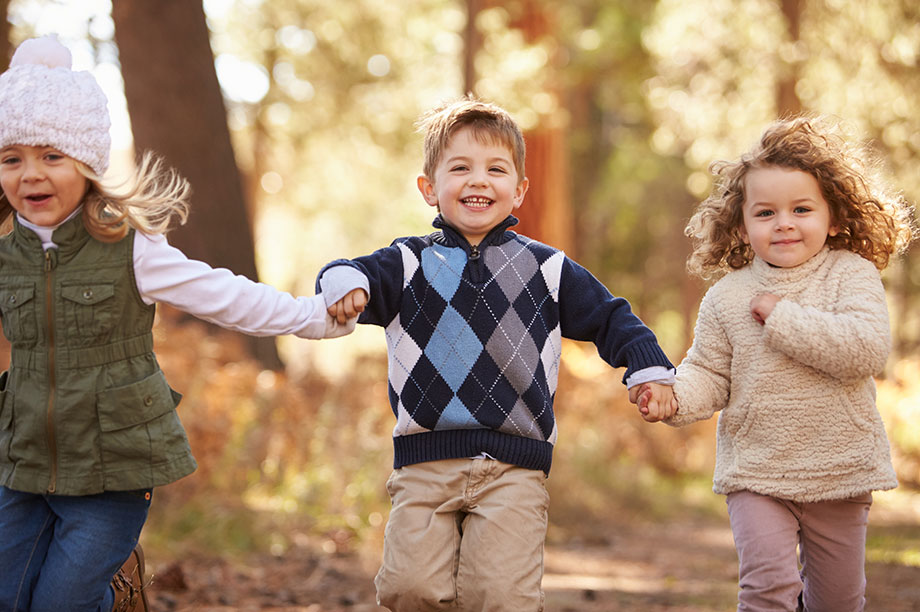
[727,491,872,612]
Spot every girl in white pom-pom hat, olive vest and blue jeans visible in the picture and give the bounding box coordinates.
[0,37,354,611]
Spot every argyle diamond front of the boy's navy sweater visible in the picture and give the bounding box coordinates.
[386,239,564,443]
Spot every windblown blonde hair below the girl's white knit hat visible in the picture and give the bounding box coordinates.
[0,152,191,242]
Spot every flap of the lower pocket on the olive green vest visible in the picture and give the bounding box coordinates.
[96,371,178,431]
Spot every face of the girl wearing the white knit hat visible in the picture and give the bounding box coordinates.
[0,145,89,227]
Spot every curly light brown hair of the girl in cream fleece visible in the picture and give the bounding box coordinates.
[684,116,914,278]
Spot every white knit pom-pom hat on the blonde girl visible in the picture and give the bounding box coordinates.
[0,35,112,177]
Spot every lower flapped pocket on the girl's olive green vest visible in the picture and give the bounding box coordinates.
[96,371,188,476]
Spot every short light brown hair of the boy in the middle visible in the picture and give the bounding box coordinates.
[417,94,526,181]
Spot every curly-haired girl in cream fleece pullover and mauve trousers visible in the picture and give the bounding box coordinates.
[639,117,912,612]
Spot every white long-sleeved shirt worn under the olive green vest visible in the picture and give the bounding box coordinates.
[19,213,355,339]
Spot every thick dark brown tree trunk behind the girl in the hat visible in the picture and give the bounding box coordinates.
[112,0,281,368]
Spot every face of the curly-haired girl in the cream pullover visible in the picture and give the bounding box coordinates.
[741,166,837,268]
